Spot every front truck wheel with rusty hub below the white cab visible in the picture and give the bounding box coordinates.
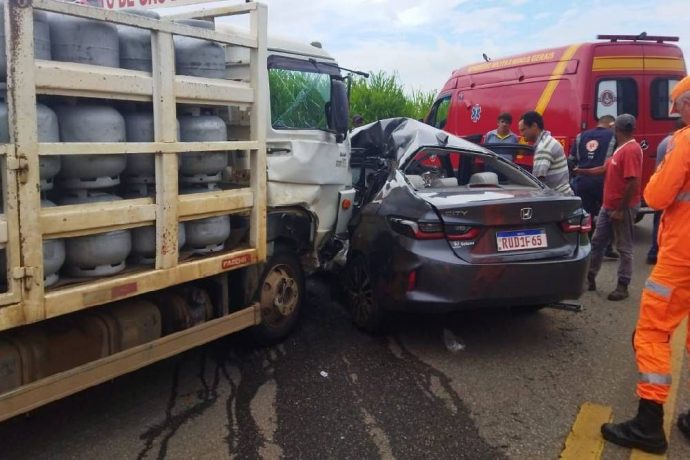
[252,249,305,345]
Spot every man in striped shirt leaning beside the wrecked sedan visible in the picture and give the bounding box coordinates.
[518,111,573,195]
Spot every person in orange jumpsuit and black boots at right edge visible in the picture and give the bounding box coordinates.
[601,77,690,454]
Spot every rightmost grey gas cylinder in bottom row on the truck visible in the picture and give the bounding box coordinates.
[180,184,230,254]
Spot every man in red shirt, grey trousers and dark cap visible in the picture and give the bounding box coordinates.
[574,113,642,301]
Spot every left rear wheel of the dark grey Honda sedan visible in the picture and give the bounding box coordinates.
[345,255,384,334]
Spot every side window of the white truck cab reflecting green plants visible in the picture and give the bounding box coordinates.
[268,56,334,130]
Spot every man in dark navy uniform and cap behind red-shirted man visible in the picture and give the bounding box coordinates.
[569,115,619,259]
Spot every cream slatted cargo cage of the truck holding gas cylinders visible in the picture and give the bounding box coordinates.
[0,0,268,331]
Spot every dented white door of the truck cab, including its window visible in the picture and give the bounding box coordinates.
[266,55,350,244]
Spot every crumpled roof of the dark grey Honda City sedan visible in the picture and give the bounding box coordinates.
[350,118,494,161]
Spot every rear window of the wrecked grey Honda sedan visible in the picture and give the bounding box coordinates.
[402,149,539,188]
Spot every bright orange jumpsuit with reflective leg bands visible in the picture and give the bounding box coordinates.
[634,127,690,403]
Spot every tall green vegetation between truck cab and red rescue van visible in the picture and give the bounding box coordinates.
[350,71,436,123]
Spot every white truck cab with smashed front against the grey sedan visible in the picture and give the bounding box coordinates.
[218,29,354,269]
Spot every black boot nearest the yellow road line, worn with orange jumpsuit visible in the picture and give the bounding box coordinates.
[601,399,668,454]
